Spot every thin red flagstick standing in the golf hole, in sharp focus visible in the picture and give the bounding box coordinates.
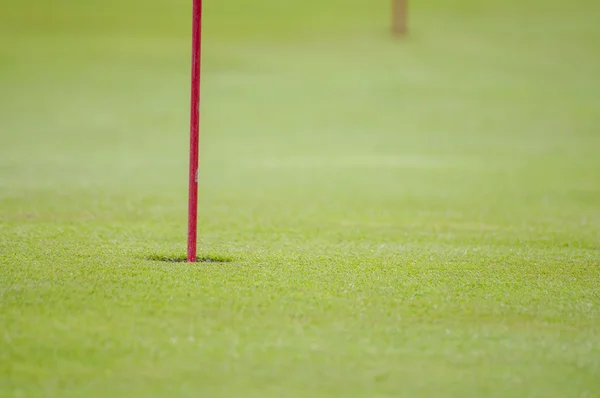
[187,0,202,263]
